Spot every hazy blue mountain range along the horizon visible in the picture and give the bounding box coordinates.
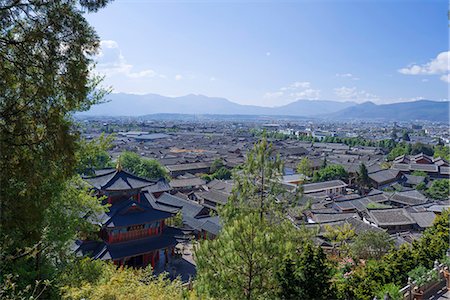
[79,93,449,122]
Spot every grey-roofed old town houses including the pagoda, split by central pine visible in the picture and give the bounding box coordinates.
[74,126,450,282]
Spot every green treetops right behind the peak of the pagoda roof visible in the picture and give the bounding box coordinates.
[119,151,169,179]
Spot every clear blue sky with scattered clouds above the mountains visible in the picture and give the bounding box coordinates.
[87,0,450,106]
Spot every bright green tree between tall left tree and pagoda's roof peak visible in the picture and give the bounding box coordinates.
[77,134,114,175]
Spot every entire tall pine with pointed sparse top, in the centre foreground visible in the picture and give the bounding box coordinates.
[195,139,308,299]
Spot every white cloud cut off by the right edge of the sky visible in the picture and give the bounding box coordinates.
[398,51,450,82]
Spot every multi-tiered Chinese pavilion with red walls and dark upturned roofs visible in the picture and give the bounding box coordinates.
[75,165,182,268]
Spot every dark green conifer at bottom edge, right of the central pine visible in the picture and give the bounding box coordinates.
[276,243,333,300]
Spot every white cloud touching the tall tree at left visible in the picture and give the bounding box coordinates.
[95,40,166,79]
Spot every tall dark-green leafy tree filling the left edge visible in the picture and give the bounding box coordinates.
[0,0,108,298]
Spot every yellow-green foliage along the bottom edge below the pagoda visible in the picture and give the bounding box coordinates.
[60,258,183,300]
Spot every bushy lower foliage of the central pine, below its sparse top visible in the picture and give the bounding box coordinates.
[195,212,294,299]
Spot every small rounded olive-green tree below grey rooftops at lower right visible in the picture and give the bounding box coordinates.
[351,231,393,259]
